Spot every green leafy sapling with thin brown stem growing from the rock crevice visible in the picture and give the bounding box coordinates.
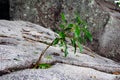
[35,13,92,68]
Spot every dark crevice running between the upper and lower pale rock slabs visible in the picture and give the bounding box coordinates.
[0,61,117,76]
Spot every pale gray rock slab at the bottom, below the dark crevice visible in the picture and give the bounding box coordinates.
[0,64,120,80]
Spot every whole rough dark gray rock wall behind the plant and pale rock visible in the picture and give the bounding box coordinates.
[10,0,120,61]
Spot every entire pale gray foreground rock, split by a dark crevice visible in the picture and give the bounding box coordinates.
[0,20,120,80]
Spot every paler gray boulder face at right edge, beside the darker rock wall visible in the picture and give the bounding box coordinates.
[99,17,120,61]
